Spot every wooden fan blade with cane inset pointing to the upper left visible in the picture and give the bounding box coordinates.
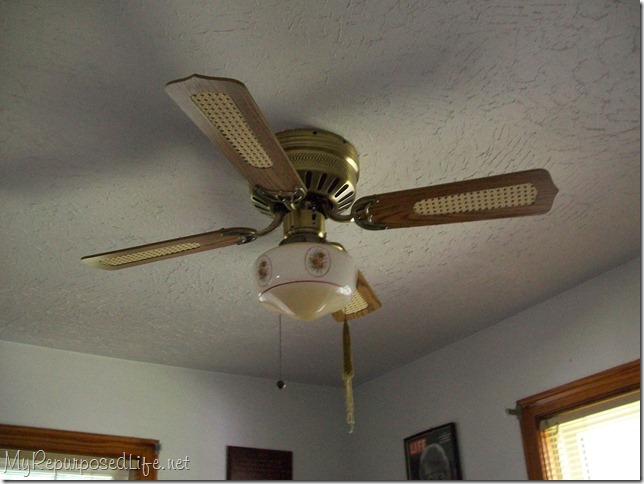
[166,74,306,193]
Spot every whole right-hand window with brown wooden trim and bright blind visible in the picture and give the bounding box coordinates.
[517,360,641,480]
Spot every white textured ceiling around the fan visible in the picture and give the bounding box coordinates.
[0,0,641,385]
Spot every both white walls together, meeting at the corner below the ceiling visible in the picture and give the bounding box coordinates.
[0,259,641,480]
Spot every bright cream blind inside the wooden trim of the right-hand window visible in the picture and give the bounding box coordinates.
[541,391,641,480]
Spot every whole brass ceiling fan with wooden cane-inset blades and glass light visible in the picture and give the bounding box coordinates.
[82,75,558,321]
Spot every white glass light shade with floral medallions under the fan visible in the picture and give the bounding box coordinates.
[255,242,358,321]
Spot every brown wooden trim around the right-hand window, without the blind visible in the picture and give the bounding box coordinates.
[517,359,641,480]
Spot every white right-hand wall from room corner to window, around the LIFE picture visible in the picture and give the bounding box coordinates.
[351,258,641,480]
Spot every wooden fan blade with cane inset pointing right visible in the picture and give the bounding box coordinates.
[352,169,558,230]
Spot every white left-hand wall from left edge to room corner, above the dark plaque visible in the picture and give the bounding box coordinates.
[0,341,348,480]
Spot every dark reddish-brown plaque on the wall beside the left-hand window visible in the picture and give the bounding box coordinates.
[226,445,293,481]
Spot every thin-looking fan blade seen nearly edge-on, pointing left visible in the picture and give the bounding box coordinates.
[81,228,256,270]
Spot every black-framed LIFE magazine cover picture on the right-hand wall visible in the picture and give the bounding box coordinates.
[405,422,463,481]
